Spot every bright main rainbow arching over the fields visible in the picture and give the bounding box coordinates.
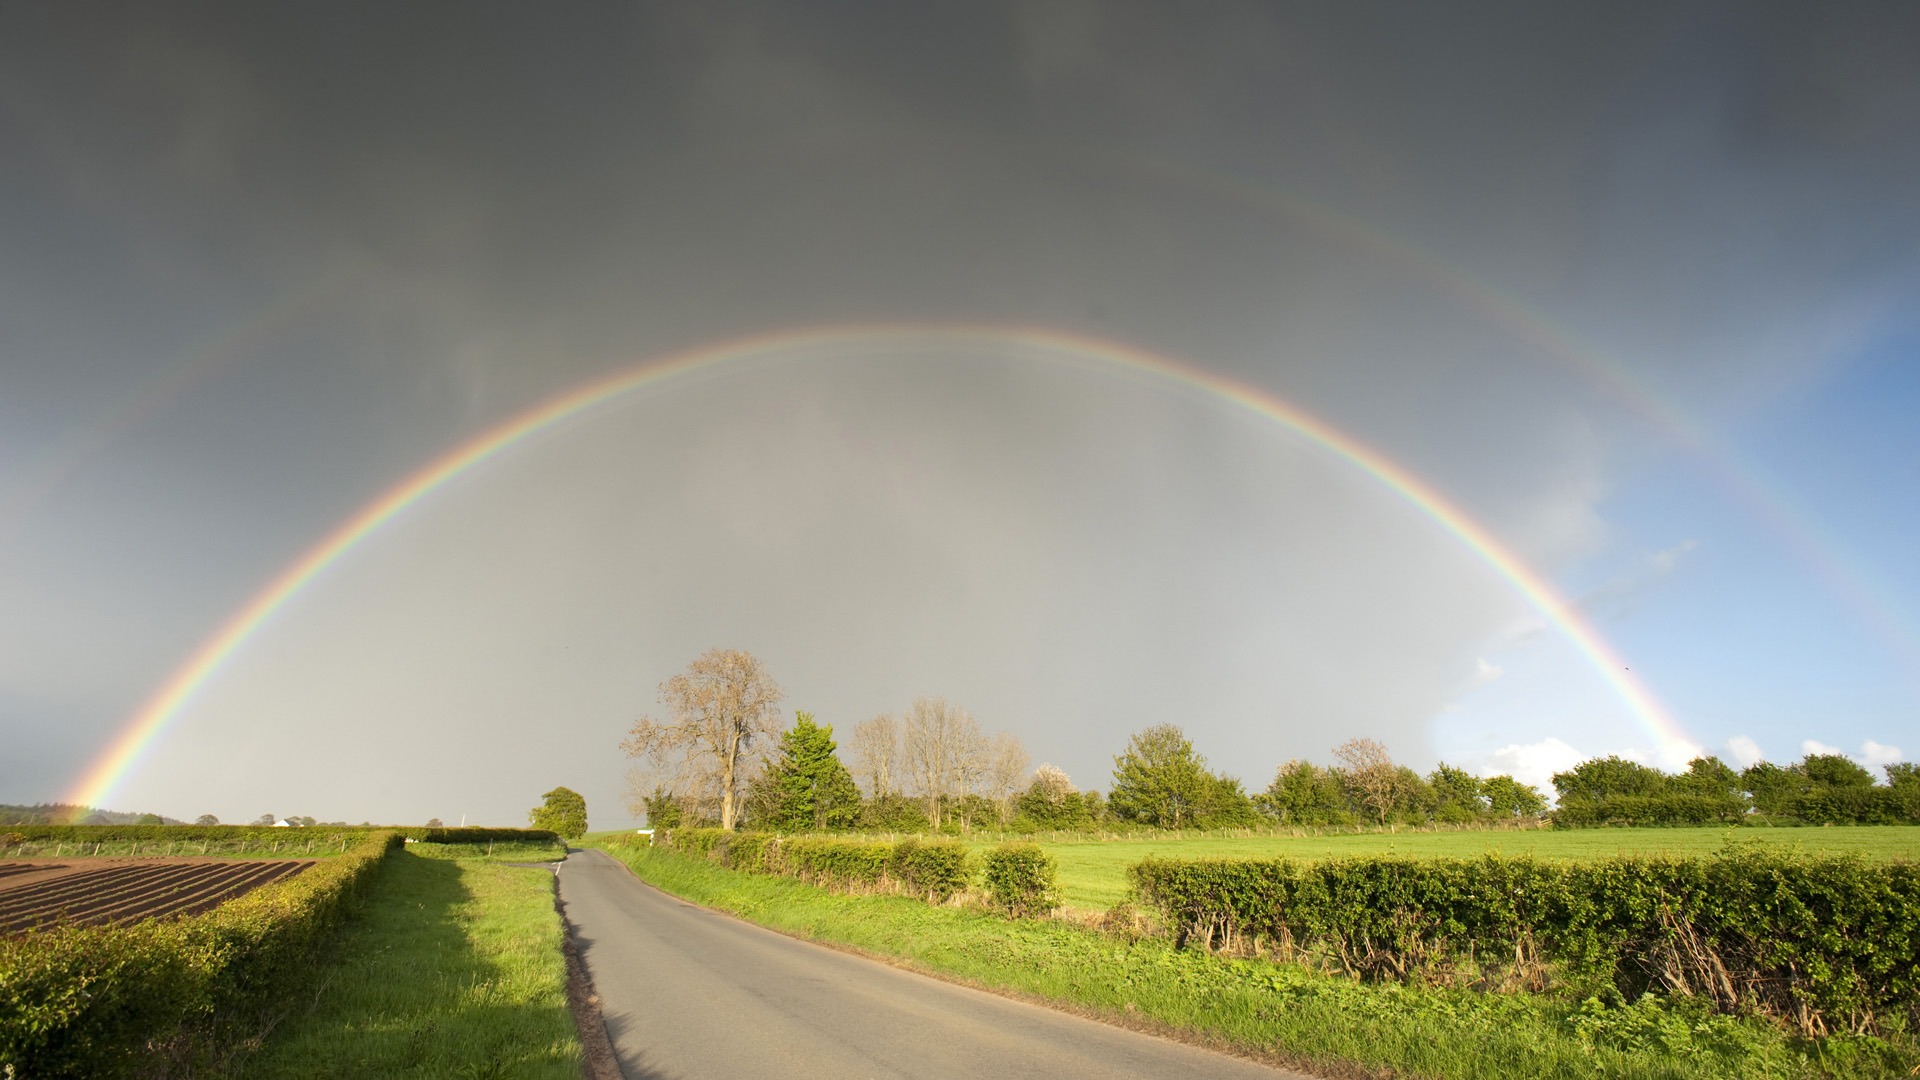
[65,325,1693,805]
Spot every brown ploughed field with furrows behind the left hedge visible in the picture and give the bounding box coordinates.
[0,859,313,936]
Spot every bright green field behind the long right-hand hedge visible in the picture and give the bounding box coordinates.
[1041,824,1920,911]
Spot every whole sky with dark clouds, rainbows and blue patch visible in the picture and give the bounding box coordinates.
[0,0,1920,828]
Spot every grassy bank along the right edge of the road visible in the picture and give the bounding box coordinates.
[595,847,1920,1080]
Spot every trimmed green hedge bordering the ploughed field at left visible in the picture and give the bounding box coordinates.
[0,826,401,1080]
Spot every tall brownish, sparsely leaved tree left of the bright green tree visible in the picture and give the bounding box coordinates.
[620,650,781,828]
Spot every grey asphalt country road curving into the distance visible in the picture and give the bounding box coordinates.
[561,851,1306,1080]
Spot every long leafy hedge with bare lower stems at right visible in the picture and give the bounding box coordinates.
[1129,849,1920,1036]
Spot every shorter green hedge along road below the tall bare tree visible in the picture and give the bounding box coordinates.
[653,828,973,903]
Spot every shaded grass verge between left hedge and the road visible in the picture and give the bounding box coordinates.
[232,844,580,1080]
